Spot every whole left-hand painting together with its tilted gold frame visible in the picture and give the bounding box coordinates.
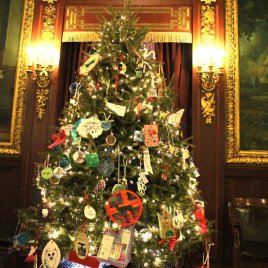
[0,0,34,154]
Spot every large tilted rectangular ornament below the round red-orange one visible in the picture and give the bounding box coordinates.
[97,226,134,267]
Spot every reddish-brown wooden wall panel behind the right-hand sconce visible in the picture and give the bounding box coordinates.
[192,0,225,263]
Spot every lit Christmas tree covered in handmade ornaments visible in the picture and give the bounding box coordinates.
[14,2,208,268]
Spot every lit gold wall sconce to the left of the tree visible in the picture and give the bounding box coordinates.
[26,45,55,120]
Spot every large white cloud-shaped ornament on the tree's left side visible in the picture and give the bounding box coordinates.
[76,115,103,139]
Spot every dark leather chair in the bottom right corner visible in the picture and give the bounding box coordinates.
[228,198,268,268]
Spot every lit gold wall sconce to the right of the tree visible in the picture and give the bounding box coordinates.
[196,47,224,125]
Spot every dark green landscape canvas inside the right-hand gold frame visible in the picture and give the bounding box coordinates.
[238,0,268,150]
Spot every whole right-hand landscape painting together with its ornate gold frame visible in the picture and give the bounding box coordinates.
[225,0,268,164]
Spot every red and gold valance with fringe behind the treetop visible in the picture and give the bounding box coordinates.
[62,5,192,43]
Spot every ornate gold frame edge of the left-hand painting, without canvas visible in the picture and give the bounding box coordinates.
[0,0,34,155]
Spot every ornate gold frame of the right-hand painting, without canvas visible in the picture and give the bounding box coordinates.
[225,0,268,164]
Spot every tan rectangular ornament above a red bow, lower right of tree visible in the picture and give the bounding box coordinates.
[157,212,175,239]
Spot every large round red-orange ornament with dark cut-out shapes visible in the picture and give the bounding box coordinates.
[106,190,142,226]
